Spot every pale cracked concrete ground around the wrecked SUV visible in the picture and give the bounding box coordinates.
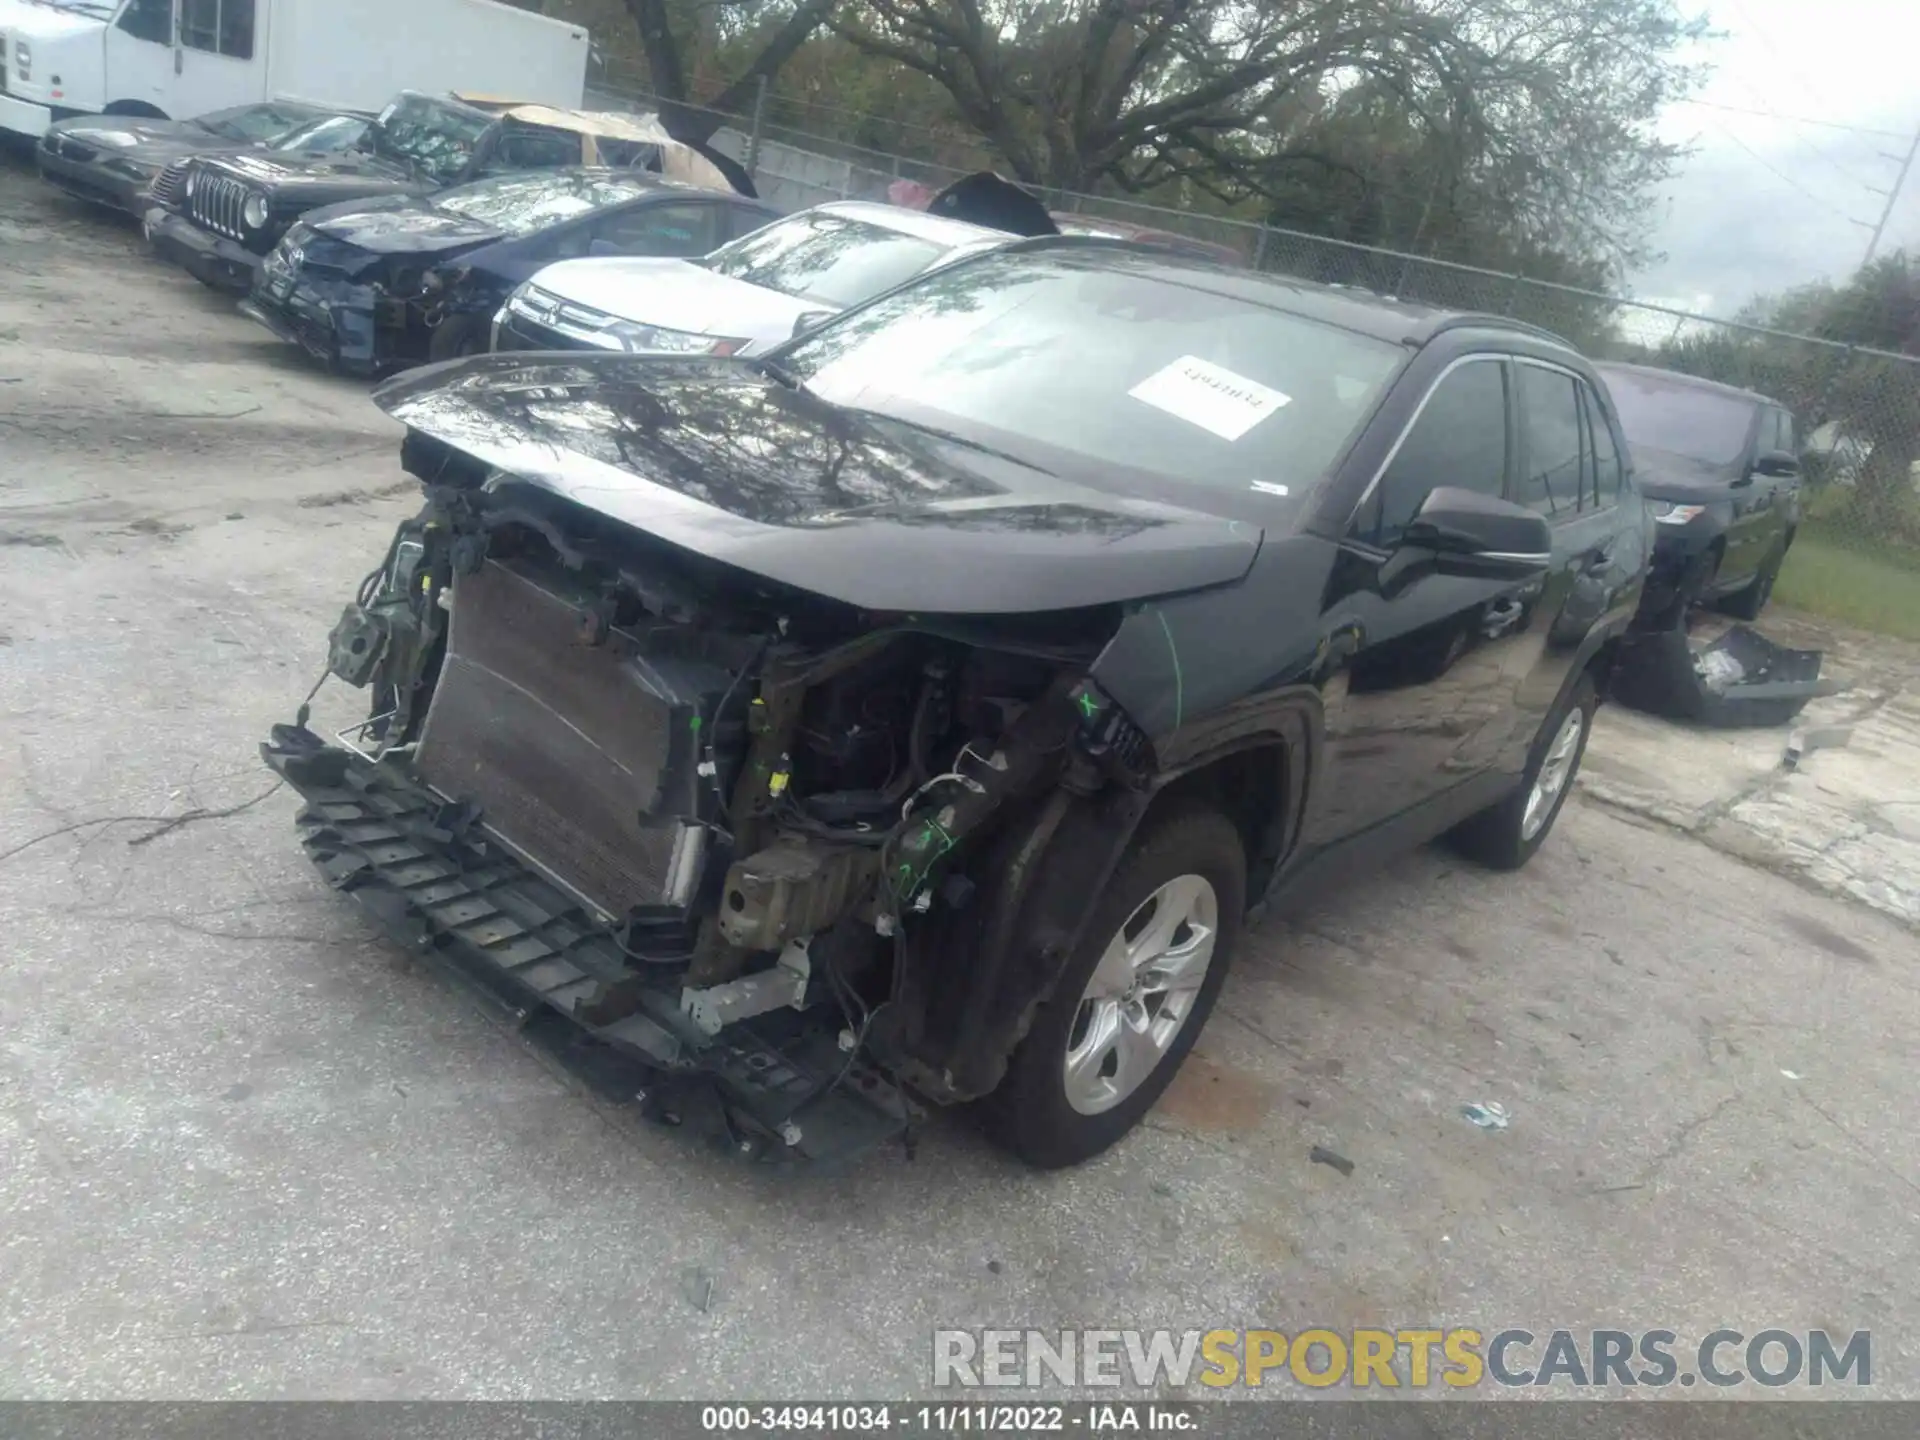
[0,159,1920,1398]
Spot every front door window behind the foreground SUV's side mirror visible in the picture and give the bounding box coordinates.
[1352,359,1507,549]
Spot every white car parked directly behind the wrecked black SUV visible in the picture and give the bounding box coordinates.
[493,200,1014,355]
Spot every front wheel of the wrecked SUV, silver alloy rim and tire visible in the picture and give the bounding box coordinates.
[981,808,1246,1169]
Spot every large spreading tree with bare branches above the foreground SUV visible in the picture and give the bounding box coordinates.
[829,0,1701,272]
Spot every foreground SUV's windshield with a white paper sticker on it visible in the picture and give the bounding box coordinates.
[780,252,1404,499]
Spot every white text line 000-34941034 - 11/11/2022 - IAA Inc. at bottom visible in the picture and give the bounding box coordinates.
[701,1402,1200,1436]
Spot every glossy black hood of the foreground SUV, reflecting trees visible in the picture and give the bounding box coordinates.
[374,353,1261,614]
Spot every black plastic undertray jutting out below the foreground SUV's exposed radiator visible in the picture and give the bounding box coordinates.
[261,726,912,1164]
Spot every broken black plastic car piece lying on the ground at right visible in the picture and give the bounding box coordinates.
[1613,624,1839,728]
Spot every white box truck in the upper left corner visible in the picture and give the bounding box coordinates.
[0,0,588,136]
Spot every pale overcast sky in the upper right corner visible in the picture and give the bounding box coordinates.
[1632,0,1920,315]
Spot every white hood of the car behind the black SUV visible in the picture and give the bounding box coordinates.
[534,257,826,349]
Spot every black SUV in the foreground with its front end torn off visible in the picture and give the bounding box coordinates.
[265,238,1651,1165]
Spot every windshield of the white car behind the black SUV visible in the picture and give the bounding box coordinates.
[697,213,948,309]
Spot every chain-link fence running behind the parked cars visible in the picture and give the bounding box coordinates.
[595,78,1920,639]
